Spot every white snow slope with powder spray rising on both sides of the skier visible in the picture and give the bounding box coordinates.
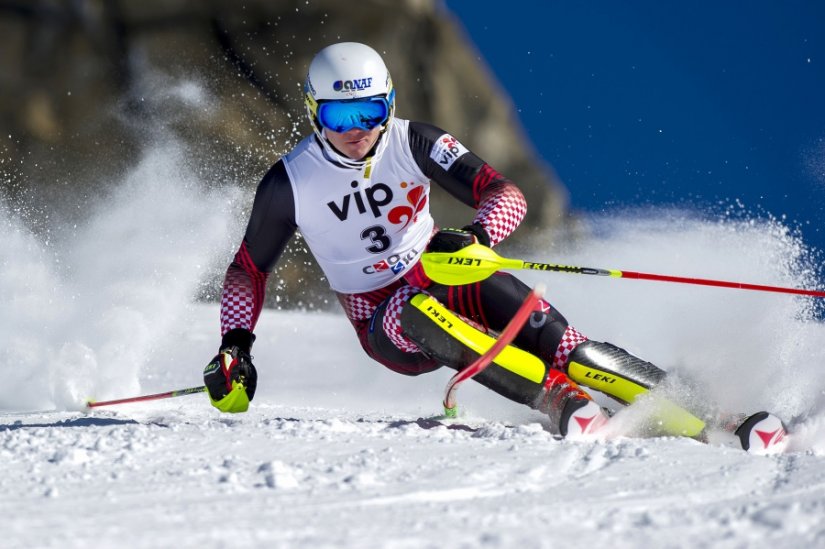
[0,145,825,549]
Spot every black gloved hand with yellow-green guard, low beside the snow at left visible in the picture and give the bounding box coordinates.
[203,329,258,413]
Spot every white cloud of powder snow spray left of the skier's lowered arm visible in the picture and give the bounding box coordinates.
[0,141,239,411]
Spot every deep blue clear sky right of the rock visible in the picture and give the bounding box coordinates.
[446,0,825,251]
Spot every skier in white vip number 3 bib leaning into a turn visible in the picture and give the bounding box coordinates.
[204,42,784,448]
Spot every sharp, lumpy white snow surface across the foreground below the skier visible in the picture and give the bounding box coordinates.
[0,399,825,547]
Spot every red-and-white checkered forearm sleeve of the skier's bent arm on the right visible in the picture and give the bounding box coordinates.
[473,164,527,246]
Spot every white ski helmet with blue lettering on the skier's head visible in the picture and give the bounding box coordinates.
[304,42,395,168]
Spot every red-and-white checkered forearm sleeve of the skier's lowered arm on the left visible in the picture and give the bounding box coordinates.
[221,241,269,335]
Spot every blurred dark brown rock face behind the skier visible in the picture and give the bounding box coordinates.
[0,0,566,308]
